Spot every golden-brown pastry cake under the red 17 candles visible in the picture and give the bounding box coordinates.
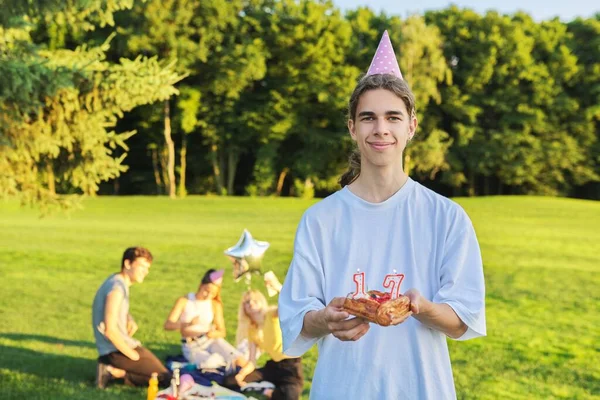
[343,290,412,326]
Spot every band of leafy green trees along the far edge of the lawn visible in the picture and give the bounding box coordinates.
[0,0,600,209]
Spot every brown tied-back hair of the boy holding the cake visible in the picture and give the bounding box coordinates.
[339,74,417,187]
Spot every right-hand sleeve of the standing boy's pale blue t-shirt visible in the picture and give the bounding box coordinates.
[433,214,486,340]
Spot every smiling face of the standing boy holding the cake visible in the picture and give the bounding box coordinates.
[348,89,417,167]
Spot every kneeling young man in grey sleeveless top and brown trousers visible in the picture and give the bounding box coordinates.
[92,247,171,389]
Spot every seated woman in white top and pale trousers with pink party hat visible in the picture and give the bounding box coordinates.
[164,269,254,373]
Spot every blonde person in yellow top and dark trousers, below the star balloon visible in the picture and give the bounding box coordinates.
[224,274,304,400]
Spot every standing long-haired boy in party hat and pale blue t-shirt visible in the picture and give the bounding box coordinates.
[279,32,486,400]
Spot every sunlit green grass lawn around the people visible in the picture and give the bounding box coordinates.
[0,197,600,400]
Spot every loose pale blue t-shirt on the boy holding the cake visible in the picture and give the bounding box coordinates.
[279,178,486,400]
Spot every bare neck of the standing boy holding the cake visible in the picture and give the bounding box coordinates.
[348,165,408,203]
